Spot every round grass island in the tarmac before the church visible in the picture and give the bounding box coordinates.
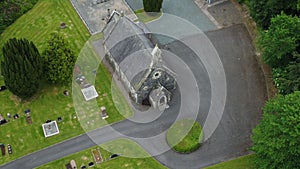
[167,119,203,153]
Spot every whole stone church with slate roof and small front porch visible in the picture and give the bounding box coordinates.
[103,11,176,110]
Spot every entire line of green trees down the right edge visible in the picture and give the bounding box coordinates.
[238,0,300,169]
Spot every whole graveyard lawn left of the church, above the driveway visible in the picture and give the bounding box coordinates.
[0,0,131,165]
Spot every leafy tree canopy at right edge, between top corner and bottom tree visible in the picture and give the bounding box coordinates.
[258,13,300,94]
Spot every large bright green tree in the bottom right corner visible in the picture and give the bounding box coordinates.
[251,91,300,169]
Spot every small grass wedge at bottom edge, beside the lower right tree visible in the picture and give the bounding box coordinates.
[205,154,255,169]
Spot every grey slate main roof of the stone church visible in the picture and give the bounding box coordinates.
[103,13,154,86]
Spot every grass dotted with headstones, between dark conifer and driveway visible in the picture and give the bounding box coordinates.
[0,78,83,164]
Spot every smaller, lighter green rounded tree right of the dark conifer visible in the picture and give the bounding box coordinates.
[43,33,76,84]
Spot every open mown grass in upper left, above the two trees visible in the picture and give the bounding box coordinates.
[0,0,90,57]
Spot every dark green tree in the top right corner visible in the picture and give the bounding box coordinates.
[249,0,300,29]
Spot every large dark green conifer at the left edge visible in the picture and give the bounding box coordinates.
[1,38,43,99]
